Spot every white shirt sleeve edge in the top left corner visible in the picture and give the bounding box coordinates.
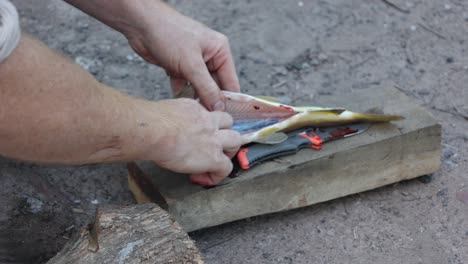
[0,0,21,63]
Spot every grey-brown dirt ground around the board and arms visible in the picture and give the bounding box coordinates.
[0,0,468,264]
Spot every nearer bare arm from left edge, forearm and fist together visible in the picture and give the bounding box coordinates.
[0,35,241,185]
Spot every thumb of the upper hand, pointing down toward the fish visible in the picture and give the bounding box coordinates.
[186,57,225,111]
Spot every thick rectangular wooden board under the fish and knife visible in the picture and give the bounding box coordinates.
[129,85,441,231]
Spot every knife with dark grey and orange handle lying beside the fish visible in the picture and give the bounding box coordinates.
[235,123,370,170]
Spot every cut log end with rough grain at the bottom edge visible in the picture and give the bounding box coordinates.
[47,203,204,264]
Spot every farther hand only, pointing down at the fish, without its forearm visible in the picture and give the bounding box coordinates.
[127,1,240,111]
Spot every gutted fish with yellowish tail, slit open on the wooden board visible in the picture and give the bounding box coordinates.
[176,87,404,144]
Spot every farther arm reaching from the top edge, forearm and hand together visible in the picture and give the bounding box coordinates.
[67,0,240,111]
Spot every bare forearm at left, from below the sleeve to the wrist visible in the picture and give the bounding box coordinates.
[0,35,158,164]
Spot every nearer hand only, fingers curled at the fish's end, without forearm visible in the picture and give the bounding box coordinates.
[141,99,242,186]
